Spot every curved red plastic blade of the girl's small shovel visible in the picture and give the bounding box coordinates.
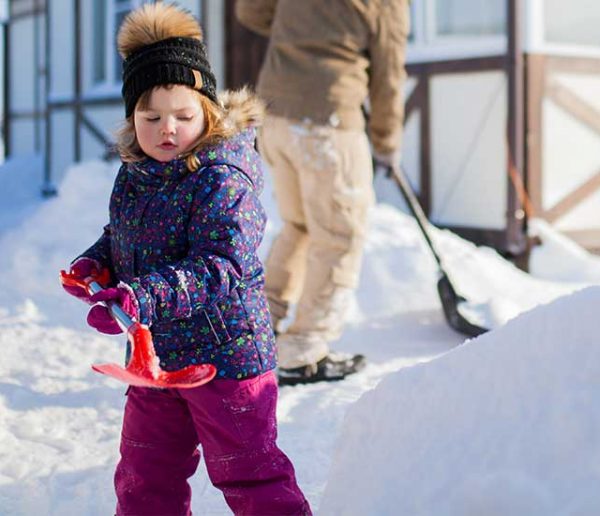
[92,364,217,389]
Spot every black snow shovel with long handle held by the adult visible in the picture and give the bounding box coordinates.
[387,162,488,337]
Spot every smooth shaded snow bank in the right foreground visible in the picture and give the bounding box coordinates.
[319,287,600,516]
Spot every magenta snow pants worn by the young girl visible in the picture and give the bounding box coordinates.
[115,372,311,516]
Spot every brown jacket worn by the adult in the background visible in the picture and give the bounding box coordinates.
[236,0,409,153]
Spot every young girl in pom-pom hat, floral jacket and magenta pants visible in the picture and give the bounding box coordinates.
[66,3,310,515]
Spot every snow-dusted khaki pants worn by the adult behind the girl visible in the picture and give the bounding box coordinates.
[258,116,375,368]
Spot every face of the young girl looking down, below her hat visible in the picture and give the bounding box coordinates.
[133,84,204,161]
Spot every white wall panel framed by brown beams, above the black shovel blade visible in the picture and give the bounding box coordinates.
[430,72,508,229]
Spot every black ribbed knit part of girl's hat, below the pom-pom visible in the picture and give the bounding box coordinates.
[121,38,217,117]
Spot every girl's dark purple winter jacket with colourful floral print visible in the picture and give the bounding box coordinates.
[83,128,276,378]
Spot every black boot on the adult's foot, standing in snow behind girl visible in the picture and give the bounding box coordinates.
[278,352,366,385]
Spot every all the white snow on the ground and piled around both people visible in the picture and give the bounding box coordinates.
[0,160,600,516]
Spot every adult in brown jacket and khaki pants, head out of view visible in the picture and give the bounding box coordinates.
[236,0,409,384]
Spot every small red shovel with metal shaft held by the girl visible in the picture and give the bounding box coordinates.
[60,271,217,389]
